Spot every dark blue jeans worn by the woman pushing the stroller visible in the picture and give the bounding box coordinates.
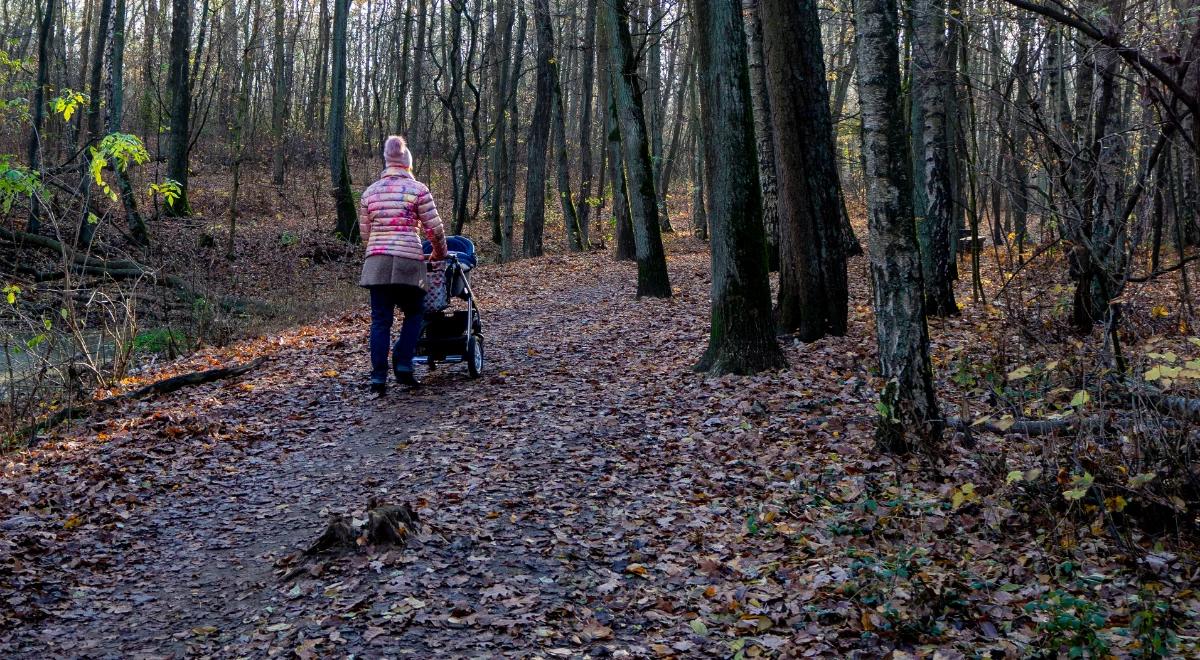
[370,284,425,383]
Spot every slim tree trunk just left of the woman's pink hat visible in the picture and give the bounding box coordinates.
[329,0,359,242]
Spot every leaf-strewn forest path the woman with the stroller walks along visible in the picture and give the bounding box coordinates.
[0,246,883,656]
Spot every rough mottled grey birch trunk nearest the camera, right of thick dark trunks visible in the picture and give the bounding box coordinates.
[856,0,942,450]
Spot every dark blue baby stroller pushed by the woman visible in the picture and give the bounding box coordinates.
[413,236,484,378]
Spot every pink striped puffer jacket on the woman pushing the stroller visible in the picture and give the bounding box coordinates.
[359,166,446,259]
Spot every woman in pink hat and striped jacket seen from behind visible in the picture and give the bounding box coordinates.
[359,136,446,395]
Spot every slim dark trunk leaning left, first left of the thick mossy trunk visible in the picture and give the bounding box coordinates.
[599,0,671,298]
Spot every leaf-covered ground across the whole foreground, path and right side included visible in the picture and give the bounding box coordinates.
[0,239,1200,658]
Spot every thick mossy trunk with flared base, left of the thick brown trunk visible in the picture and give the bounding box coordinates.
[694,0,786,374]
